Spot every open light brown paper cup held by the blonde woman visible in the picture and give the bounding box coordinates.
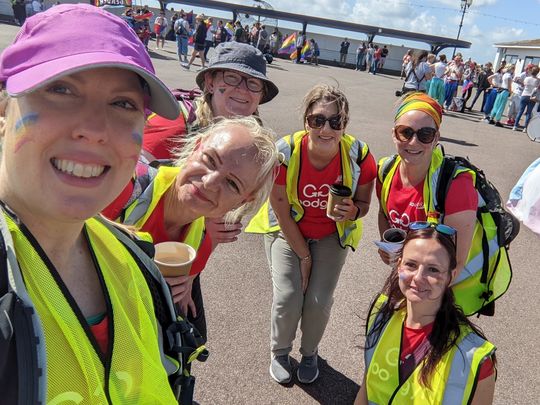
[154,242,197,277]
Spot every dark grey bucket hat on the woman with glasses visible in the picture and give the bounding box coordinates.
[195,41,279,104]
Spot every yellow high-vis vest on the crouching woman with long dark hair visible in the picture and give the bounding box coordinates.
[365,296,495,405]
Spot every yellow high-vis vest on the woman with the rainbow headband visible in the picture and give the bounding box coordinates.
[378,148,511,316]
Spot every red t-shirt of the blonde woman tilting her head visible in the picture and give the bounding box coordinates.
[102,191,212,275]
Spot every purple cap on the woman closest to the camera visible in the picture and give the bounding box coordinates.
[0,4,179,119]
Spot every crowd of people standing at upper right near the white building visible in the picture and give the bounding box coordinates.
[401,50,540,132]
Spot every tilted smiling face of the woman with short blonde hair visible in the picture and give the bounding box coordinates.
[176,125,261,218]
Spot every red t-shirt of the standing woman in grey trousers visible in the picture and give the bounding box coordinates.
[276,136,377,239]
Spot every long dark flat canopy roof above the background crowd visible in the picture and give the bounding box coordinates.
[167,0,471,52]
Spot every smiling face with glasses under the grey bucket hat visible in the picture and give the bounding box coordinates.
[204,70,264,118]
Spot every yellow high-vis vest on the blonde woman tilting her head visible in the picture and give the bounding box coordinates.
[122,166,204,251]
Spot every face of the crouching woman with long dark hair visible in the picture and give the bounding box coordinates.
[397,239,452,308]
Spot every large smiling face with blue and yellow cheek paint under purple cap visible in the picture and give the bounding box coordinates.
[0,68,145,222]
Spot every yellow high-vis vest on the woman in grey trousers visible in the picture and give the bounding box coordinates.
[246,131,369,250]
